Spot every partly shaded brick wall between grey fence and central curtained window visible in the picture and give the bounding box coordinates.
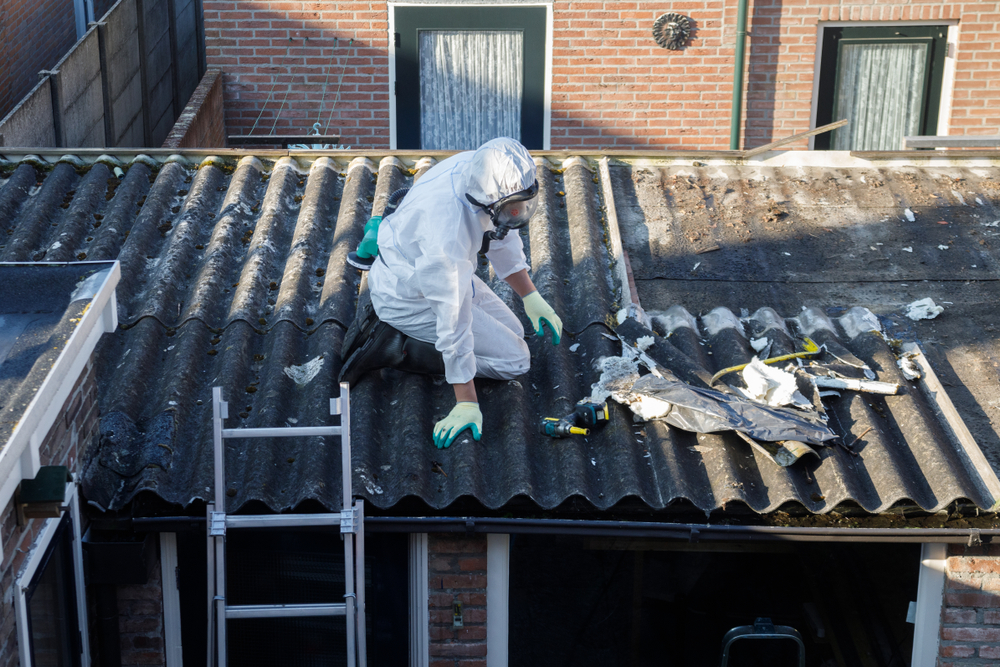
[204,0,389,148]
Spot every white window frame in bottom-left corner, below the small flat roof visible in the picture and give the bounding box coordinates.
[14,482,90,667]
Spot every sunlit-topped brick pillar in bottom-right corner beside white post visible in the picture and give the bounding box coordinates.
[938,545,1000,667]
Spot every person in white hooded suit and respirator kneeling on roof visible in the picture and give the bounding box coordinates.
[341,139,562,448]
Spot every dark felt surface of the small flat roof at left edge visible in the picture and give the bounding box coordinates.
[0,263,111,443]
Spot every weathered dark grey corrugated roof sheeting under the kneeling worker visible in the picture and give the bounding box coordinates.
[0,151,1000,513]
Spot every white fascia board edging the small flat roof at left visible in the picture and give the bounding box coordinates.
[0,260,121,507]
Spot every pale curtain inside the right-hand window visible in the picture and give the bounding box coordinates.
[833,44,929,151]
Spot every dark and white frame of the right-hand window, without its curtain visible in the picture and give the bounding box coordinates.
[809,20,955,150]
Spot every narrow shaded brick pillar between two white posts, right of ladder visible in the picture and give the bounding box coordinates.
[427,534,486,667]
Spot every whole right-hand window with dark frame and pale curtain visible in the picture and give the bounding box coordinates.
[815,26,947,151]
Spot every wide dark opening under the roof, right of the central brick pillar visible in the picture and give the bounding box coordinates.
[510,535,920,667]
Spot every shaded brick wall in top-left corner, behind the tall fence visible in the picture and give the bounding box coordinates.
[0,0,76,118]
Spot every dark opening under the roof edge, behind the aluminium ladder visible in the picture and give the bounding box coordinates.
[178,530,409,667]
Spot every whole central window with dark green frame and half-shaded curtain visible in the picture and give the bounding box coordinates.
[390,4,548,150]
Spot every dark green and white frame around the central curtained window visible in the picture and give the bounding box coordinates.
[388,2,553,150]
